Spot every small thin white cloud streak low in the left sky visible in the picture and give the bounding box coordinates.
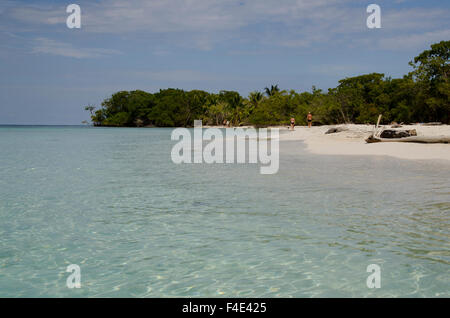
[32,38,121,59]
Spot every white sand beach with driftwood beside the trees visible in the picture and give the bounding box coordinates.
[280,124,450,162]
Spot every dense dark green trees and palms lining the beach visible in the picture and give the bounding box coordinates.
[85,41,450,127]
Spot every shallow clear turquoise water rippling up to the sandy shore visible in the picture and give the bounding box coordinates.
[0,127,450,297]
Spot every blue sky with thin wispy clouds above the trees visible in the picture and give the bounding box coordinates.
[0,0,450,125]
